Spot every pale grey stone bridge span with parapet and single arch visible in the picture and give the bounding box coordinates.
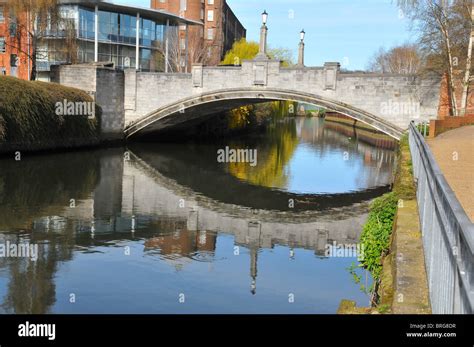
[124,61,440,139]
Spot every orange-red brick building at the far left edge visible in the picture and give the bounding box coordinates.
[0,0,31,80]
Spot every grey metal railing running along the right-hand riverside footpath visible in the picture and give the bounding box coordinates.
[409,123,474,314]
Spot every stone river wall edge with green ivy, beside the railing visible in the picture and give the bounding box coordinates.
[338,135,431,314]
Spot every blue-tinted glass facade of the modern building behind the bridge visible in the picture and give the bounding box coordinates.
[38,5,180,75]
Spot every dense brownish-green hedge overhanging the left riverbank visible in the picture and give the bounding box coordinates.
[0,76,101,150]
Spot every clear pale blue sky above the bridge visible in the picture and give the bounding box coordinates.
[112,0,415,70]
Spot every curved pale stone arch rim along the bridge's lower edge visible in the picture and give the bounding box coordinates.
[124,87,403,140]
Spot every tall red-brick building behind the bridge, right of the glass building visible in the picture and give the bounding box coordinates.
[151,0,247,65]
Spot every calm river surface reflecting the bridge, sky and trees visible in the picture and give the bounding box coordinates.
[0,118,395,313]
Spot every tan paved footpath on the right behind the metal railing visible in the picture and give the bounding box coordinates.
[427,125,474,222]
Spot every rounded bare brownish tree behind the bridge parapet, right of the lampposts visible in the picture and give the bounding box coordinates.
[368,43,421,74]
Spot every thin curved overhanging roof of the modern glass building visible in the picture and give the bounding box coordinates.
[58,0,204,25]
